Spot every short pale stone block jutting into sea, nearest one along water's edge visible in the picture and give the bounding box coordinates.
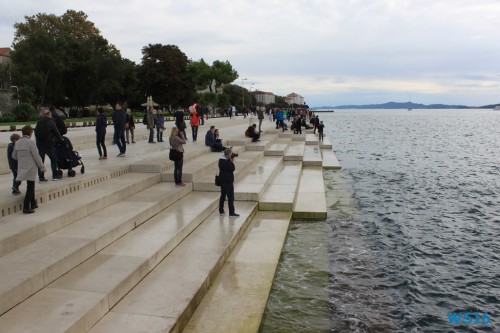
[292,167,326,219]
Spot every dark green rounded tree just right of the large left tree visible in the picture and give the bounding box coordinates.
[138,44,194,106]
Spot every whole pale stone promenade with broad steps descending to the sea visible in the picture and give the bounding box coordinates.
[0,117,340,333]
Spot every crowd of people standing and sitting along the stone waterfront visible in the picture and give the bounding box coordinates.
[7,103,324,216]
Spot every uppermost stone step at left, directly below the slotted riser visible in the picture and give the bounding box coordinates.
[0,173,161,256]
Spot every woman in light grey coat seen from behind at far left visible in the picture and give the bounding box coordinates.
[12,124,46,214]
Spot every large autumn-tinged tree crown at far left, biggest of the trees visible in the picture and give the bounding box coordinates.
[12,10,131,107]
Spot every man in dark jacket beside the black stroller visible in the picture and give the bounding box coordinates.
[35,111,63,182]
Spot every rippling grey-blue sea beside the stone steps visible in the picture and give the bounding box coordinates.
[260,109,500,333]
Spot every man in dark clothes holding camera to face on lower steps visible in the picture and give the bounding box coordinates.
[219,149,240,217]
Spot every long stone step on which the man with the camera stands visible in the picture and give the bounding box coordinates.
[89,202,257,333]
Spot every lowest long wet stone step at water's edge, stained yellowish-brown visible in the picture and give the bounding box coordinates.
[183,212,291,333]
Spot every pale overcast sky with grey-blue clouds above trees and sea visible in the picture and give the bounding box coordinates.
[0,0,500,106]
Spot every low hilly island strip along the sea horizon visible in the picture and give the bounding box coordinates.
[311,102,500,110]
